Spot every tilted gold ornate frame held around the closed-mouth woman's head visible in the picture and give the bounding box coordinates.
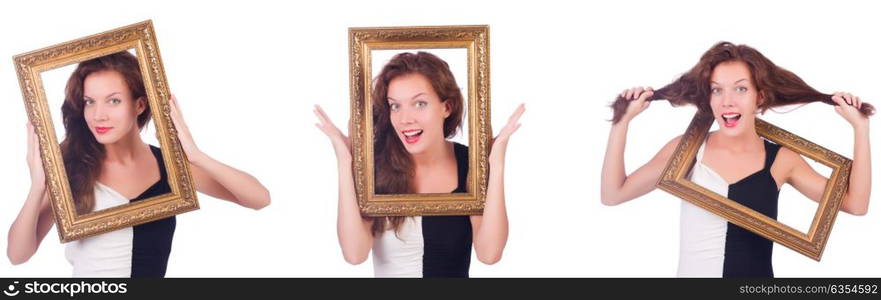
[13,20,199,243]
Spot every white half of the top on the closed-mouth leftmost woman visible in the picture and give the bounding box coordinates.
[64,182,134,277]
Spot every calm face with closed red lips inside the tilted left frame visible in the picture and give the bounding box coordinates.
[83,71,145,145]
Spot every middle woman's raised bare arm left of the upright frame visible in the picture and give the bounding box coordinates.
[315,105,373,265]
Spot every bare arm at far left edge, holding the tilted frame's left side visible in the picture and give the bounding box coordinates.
[6,122,54,265]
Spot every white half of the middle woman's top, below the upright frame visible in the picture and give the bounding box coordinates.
[372,216,425,277]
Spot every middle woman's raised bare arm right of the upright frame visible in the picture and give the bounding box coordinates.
[471,104,526,265]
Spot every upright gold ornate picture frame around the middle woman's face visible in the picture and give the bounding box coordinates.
[349,26,492,216]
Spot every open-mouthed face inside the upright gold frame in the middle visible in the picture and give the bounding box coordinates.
[388,73,450,154]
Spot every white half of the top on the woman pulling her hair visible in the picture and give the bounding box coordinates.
[677,141,728,277]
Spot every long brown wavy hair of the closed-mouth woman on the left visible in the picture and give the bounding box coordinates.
[61,51,150,214]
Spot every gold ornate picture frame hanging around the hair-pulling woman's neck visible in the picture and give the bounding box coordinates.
[658,112,852,261]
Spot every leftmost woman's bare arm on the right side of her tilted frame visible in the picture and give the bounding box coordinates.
[170,96,270,209]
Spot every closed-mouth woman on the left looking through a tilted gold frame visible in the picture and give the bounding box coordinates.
[7,51,270,277]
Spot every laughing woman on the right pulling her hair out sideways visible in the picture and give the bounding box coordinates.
[601,42,874,277]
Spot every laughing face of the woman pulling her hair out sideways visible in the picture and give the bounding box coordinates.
[710,61,762,136]
